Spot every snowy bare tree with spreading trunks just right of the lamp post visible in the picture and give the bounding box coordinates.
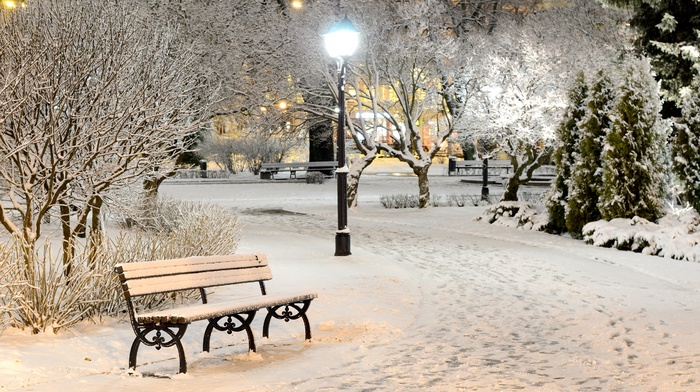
[330,0,478,208]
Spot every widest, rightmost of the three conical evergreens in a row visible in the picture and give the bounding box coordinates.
[598,60,667,221]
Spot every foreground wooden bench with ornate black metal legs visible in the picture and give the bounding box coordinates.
[115,254,317,373]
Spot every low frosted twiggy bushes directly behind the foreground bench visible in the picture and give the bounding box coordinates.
[0,200,240,333]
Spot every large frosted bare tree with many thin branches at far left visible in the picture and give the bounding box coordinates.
[0,0,204,273]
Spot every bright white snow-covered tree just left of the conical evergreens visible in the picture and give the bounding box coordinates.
[462,0,625,201]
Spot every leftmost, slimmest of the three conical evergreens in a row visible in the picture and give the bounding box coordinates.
[547,72,588,233]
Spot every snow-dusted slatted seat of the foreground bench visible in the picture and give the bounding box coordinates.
[136,293,318,324]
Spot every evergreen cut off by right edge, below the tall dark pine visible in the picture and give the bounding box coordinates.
[673,78,700,211]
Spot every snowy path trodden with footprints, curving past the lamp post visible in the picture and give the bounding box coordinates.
[234,208,700,391]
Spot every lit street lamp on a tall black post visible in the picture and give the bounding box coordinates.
[323,16,360,256]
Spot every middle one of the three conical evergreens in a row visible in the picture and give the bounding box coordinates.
[566,70,615,238]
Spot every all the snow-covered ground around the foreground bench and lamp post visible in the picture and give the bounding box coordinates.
[0,161,700,391]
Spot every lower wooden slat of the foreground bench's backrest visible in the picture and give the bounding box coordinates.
[122,266,272,296]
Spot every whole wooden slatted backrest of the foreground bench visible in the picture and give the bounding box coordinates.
[115,254,272,297]
